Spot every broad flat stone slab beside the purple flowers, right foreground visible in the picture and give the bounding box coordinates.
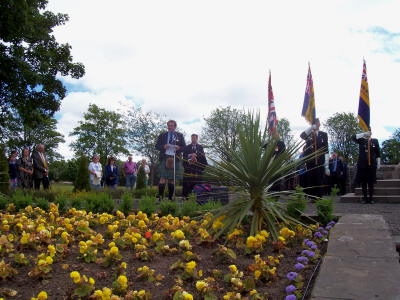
[311,214,400,300]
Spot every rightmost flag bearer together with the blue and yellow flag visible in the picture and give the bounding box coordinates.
[353,60,381,203]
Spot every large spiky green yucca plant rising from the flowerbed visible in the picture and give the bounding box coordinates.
[205,113,319,239]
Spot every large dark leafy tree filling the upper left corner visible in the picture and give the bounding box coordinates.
[0,0,85,129]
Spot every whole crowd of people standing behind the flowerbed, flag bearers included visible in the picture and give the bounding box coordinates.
[8,119,380,203]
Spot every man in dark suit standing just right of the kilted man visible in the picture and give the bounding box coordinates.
[182,134,208,198]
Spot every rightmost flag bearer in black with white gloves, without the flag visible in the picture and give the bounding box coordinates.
[353,131,381,203]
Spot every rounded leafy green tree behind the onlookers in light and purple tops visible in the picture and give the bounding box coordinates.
[70,104,129,166]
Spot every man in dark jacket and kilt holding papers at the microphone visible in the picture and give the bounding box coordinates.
[155,120,186,200]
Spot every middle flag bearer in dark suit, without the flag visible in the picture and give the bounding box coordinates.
[300,119,330,197]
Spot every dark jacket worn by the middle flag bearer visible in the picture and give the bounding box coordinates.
[300,131,329,168]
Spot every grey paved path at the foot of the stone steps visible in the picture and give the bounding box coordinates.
[305,198,400,236]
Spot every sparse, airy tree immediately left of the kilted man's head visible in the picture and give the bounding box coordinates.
[125,107,167,182]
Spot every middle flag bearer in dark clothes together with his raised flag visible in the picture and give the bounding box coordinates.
[300,64,329,197]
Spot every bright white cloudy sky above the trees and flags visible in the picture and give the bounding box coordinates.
[47,0,400,159]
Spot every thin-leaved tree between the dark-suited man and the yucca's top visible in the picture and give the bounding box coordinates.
[201,106,247,159]
